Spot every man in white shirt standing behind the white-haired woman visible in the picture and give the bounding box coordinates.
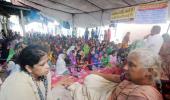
[145,25,163,54]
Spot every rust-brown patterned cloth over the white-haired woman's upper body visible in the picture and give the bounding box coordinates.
[108,80,163,100]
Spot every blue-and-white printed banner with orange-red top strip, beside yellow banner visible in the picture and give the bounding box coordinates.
[135,2,168,24]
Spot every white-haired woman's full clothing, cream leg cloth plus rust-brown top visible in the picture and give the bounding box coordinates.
[68,74,163,100]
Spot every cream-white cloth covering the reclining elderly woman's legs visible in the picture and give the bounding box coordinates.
[68,74,117,100]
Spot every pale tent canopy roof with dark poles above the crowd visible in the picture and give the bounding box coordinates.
[13,0,159,27]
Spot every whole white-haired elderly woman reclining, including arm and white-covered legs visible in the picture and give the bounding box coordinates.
[51,49,163,100]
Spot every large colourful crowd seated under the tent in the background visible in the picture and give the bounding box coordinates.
[0,26,129,82]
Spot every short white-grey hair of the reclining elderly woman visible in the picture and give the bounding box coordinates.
[128,48,161,80]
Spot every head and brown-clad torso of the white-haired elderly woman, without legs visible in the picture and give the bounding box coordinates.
[109,49,162,100]
